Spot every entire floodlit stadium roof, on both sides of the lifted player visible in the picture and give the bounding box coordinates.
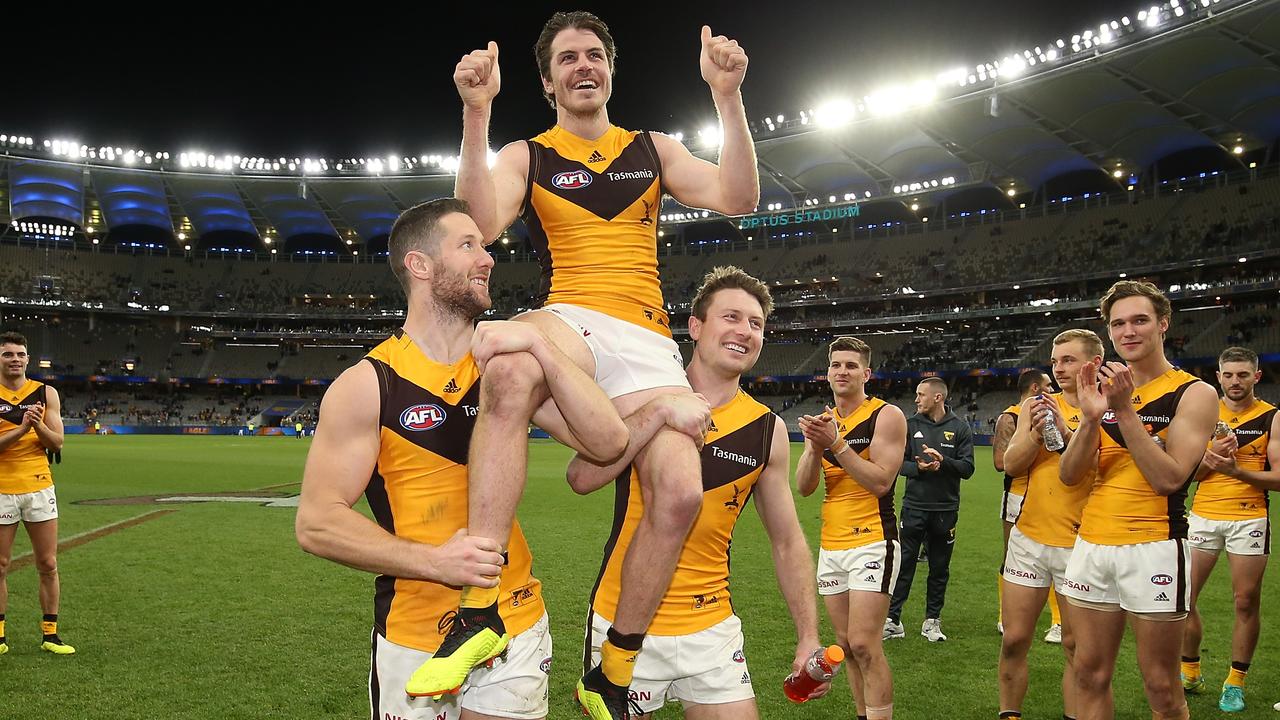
[0,0,1280,251]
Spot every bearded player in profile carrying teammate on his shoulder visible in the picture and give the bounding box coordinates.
[297,199,626,720]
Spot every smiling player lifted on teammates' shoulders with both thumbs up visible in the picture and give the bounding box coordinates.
[406,12,760,719]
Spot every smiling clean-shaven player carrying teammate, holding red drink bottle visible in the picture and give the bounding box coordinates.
[568,266,827,720]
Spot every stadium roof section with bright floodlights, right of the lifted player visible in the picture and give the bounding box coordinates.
[721,3,1280,206]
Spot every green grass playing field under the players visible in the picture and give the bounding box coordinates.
[0,436,1280,720]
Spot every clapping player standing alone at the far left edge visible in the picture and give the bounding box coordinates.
[0,333,76,655]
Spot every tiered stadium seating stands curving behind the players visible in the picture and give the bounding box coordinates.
[0,170,1280,420]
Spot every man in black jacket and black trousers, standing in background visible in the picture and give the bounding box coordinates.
[884,378,973,642]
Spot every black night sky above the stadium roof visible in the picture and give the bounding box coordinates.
[0,0,1121,158]
